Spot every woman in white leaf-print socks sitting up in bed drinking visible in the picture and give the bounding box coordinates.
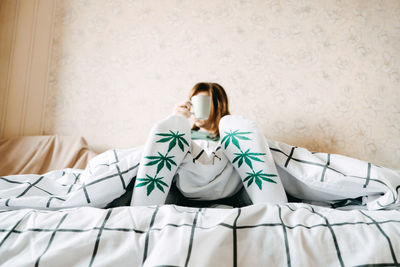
[132,83,287,206]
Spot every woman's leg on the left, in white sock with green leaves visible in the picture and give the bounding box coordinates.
[131,115,191,206]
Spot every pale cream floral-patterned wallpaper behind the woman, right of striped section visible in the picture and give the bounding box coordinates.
[45,0,400,169]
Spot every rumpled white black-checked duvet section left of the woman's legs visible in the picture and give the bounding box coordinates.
[0,147,142,209]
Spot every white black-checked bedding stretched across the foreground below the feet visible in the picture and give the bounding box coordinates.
[0,203,400,267]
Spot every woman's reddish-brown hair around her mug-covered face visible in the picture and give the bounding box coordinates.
[189,82,230,137]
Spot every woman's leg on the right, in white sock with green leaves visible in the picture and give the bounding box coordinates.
[219,115,287,204]
